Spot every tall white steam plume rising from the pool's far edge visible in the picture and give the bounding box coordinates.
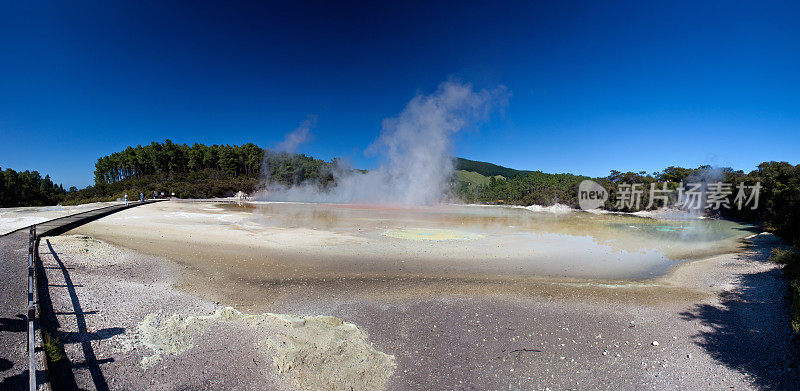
[258,80,508,205]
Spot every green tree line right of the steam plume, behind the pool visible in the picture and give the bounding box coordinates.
[453,162,800,242]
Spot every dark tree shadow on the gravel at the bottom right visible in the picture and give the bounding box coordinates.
[681,248,800,390]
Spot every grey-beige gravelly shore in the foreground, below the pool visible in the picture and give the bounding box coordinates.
[41,201,798,390]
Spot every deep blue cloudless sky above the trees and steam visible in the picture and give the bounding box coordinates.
[0,1,800,187]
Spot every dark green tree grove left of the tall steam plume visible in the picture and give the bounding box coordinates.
[64,140,336,204]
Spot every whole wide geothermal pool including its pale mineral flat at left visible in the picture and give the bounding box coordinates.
[67,202,751,284]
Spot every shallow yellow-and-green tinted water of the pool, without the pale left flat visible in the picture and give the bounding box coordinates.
[220,203,751,279]
